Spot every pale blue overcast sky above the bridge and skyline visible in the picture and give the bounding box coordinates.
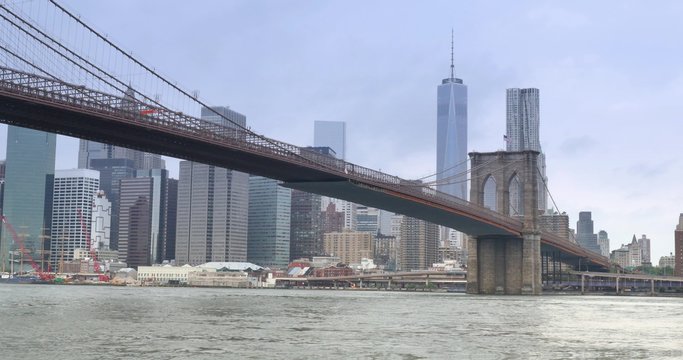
[0,0,683,264]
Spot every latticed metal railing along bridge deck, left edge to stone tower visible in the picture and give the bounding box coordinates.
[0,67,521,228]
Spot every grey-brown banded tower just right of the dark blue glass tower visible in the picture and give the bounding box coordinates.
[118,177,154,268]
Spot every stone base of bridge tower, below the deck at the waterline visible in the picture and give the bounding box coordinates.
[467,233,542,295]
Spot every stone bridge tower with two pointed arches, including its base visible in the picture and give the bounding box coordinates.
[467,150,542,295]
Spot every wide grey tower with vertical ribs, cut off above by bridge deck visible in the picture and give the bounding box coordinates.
[175,161,249,265]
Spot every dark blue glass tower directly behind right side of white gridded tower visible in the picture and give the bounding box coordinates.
[90,158,136,250]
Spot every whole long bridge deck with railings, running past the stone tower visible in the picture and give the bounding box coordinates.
[0,67,608,265]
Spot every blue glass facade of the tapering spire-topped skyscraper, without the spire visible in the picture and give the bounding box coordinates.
[436,73,467,200]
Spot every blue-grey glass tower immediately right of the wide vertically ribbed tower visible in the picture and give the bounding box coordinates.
[247,175,292,268]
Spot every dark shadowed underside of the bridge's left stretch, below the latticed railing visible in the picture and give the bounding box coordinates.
[0,95,344,181]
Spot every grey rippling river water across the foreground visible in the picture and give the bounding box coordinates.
[0,285,683,359]
